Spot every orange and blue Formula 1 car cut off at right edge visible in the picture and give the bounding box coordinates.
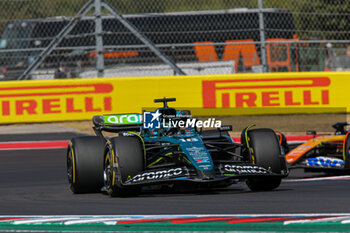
[280,122,350,172]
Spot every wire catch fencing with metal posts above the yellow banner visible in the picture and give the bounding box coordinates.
[0,0,350,80]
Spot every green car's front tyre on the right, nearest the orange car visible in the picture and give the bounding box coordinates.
[242,129,283,191]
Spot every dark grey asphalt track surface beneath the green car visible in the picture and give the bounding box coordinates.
[0,133,350,215]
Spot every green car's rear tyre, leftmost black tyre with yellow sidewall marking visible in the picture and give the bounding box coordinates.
[67,136,105,193]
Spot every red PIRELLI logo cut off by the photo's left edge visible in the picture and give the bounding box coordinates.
[0,83,113,116]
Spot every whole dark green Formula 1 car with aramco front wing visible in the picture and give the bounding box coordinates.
[67,98,288,196]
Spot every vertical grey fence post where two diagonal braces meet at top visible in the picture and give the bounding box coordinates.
[95,0,104,77]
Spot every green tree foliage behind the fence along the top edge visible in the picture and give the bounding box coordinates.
[0,0,350,40]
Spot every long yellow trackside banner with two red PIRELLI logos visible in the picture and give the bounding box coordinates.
[0,72,350,123]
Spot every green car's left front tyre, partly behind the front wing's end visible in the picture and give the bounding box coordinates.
[104,137,144,197]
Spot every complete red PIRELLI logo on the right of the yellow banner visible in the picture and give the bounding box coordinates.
[202,77,331,108]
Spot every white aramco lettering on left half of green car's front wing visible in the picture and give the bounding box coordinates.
[128,168,184,182]
